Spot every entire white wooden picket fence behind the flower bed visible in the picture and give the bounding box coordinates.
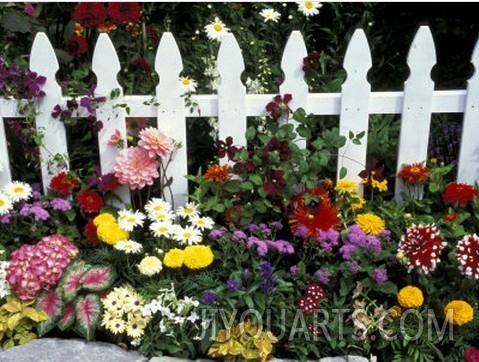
[0,26,479,205]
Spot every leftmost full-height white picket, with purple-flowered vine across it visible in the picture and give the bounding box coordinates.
[30,33,68,191]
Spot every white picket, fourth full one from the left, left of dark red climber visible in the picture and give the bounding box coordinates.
[217,34,246,146]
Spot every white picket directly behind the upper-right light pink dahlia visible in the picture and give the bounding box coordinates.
[155,32,188,206]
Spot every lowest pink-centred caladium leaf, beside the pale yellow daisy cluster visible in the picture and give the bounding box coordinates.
[73,293,103,341]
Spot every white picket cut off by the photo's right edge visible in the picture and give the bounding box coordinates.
[457,34,479,185]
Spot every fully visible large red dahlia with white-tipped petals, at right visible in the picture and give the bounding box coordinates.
[398,224,447,274]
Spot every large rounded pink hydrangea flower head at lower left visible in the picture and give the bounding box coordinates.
[6,234,79,300]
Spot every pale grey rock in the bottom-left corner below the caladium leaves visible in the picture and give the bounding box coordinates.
[0,338,148,362]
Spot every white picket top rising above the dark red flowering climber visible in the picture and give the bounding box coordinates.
[279,30,308,148]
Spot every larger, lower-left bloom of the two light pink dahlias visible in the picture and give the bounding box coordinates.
[114,147,159,189]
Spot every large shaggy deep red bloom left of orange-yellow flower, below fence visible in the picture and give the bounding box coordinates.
[289,187,339,238]
